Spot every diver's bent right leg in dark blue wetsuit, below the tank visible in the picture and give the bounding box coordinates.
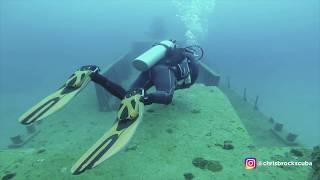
[146,66,176,104]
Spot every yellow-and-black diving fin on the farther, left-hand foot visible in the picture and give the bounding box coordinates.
[19,67,93,125]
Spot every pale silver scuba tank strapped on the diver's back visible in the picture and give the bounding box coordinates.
[132,40,176,71]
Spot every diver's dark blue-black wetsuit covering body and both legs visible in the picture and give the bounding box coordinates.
[91,48,199,105]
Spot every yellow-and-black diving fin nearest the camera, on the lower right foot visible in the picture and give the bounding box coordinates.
[71,91,144,175]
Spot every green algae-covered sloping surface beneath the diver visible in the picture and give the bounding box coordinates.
[0,84,311,180]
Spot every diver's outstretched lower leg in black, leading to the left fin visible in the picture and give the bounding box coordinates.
[90,72,126,100]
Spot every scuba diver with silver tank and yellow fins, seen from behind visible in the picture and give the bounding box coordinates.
[19,40,203,175]
